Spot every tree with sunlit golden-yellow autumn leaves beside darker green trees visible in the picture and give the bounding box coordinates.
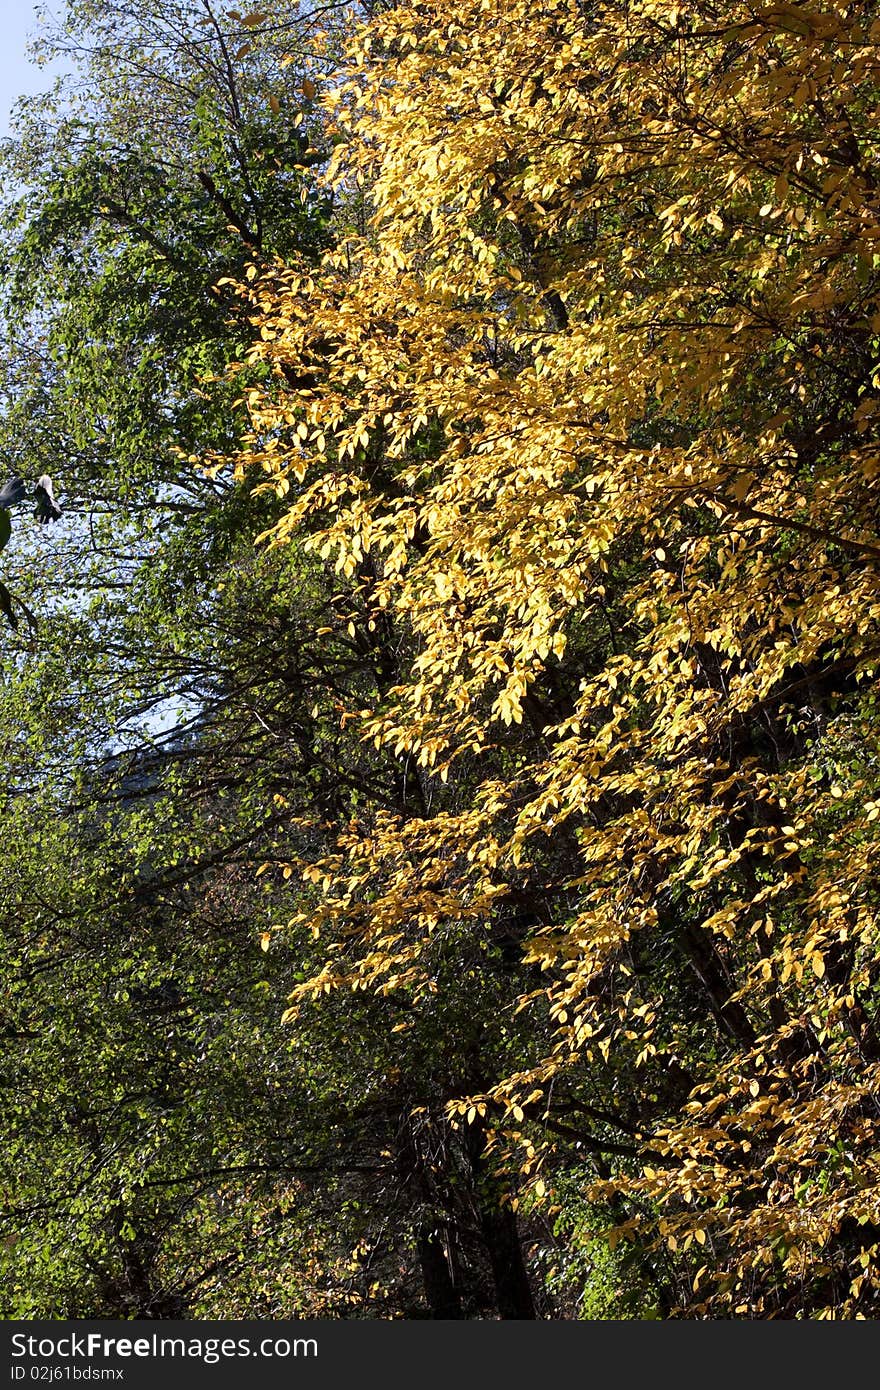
[221,0,880,1318]
